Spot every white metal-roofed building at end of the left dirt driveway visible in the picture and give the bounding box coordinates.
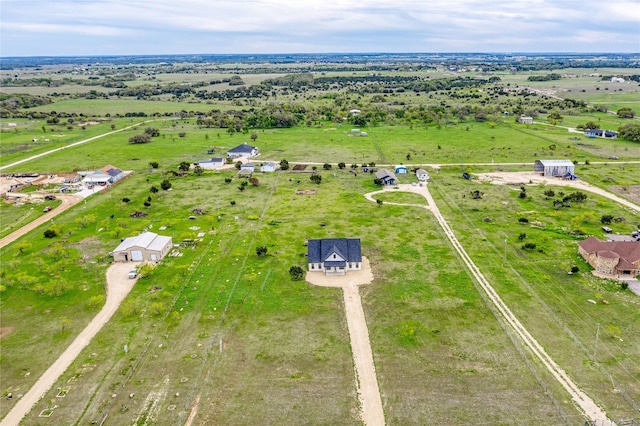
[111,232,173,262]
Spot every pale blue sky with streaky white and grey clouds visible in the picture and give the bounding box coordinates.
[0,0,640,56]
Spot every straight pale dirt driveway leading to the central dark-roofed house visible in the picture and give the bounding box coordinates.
[306,257,384,426]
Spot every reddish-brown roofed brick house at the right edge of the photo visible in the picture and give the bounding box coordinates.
[578,237,640,278]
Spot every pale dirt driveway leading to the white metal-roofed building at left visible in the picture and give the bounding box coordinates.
[0,262,137,426]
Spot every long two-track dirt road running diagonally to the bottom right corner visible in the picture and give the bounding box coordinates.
[366,185,614,425]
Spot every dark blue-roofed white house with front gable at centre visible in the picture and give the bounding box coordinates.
[307,238,362,275]
